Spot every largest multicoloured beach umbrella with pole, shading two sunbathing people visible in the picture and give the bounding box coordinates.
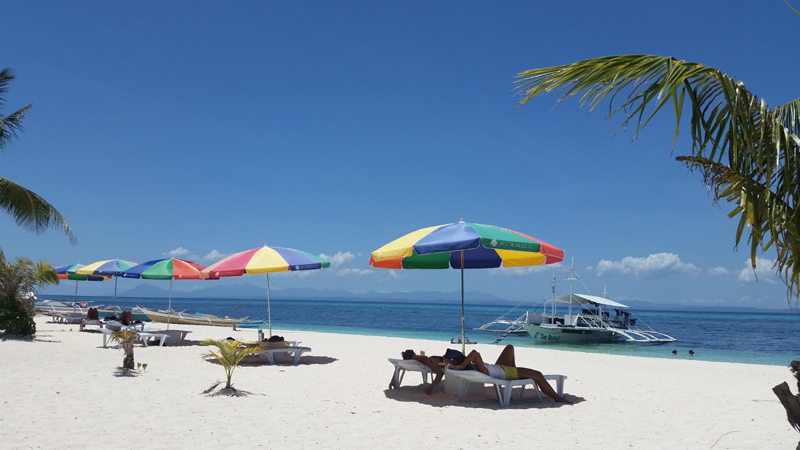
[369,219,564,351]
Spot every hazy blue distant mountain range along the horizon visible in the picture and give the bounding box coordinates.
[119,282,794,314]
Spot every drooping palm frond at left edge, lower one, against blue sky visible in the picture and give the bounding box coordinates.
[0,177,77,244]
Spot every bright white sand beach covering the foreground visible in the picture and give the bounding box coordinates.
[0,316,800,449]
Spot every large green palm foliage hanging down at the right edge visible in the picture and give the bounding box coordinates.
[517,55,800,299]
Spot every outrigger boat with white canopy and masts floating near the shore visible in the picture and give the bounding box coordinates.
[475,266,677,344]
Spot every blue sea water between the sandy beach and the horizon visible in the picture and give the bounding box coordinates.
[46,295,800,366]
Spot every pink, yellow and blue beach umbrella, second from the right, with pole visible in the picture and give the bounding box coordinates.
[202,245,331,336]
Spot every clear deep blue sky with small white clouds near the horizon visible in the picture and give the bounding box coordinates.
[0,0,800,308]
